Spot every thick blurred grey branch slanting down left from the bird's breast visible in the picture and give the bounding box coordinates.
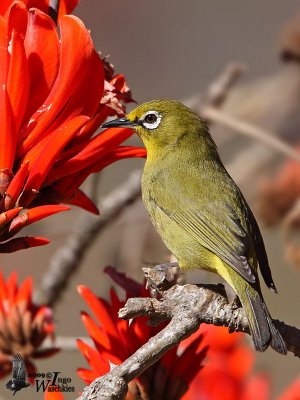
[34,171,141,306]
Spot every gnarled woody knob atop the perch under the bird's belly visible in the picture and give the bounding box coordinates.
[143,262,181,297]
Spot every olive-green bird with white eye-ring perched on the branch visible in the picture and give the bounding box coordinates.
[102,100,287,354]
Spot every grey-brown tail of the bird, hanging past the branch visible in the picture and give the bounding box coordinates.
[239,285,287,354]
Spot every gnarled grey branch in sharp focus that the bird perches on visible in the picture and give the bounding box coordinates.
[77,269,300,400]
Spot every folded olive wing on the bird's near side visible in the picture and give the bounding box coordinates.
[156,203,256,283]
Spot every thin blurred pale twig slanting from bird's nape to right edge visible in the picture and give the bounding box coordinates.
[201,107,300,161]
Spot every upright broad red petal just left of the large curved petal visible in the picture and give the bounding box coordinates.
[24,10,60,125]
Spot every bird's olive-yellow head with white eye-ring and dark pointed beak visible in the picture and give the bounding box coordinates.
[102,100,206,152]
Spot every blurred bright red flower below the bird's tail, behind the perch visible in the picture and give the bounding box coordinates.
[183,324,270,400]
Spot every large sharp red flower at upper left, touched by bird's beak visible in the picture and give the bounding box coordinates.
[0,0,145,252]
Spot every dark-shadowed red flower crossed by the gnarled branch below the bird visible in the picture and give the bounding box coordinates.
[77,271,207,400]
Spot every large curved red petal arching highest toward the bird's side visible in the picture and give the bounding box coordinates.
[18,16,103,156]
